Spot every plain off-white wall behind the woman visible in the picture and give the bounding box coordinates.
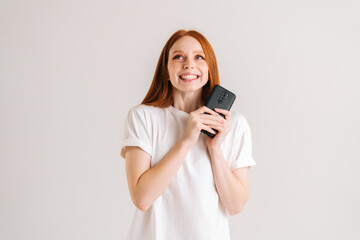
[0,0,360,240]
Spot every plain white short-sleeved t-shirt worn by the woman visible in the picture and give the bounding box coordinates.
[121,104,256,240]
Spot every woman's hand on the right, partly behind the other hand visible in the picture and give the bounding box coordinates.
[206,108,231,151]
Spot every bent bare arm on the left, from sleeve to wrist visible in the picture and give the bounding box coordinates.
[125,140,191,211]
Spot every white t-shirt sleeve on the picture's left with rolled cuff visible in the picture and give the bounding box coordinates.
[120,108,152,158]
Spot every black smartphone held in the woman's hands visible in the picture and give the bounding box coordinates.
[201,85,236,138]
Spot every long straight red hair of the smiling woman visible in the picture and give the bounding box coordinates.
[141,29,220,108]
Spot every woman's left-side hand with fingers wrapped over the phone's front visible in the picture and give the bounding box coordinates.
[182,106,225,146]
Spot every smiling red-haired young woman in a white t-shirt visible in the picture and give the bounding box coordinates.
[121,30,256,240]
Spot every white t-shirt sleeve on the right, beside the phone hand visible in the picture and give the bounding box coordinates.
[230,115,256,170]
